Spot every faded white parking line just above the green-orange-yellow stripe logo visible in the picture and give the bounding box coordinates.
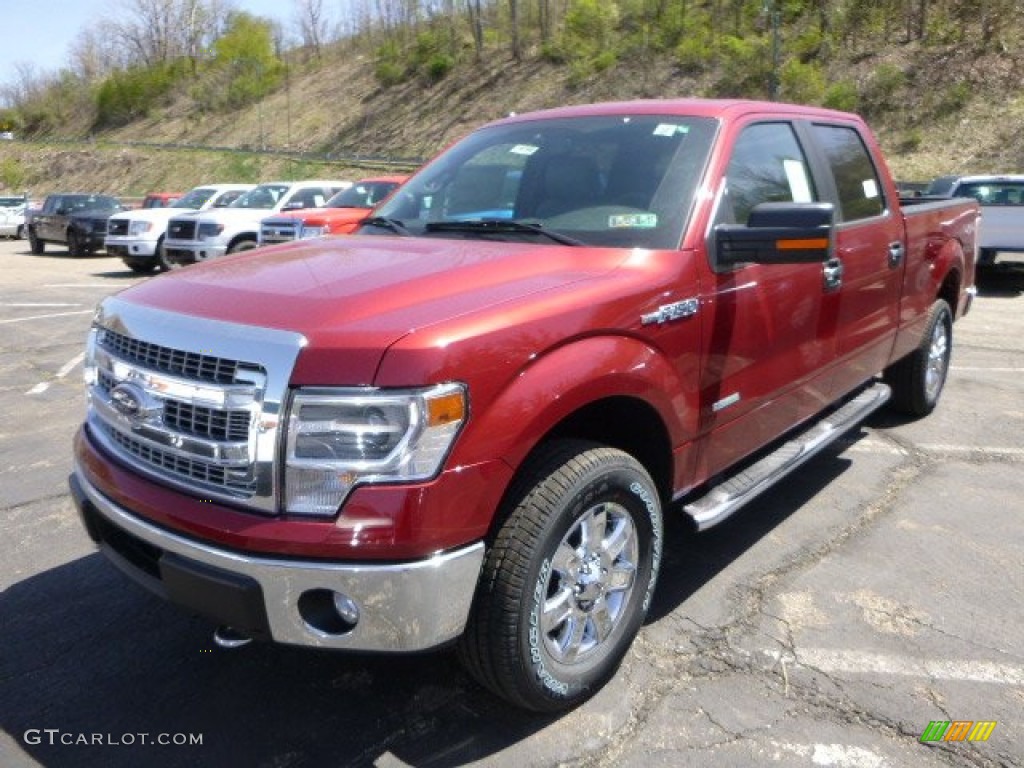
[763,648,1024,686]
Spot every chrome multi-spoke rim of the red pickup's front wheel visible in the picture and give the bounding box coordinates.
[541,503,639,664]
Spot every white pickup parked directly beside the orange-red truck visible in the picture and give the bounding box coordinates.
[164,180,351,265]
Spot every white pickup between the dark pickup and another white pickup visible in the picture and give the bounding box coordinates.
[103,184,256,274]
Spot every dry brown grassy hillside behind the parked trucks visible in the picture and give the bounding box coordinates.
[0,39,1024,196]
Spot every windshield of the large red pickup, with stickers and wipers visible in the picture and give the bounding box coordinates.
[360,115,717,248]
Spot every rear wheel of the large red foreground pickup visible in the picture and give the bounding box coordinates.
[885,299,953,418]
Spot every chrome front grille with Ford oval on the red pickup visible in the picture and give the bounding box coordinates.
[85,297,305,514]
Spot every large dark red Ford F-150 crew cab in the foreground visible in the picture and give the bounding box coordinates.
[71,100,978,711]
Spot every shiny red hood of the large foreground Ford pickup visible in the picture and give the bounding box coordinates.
[120,236,629,385]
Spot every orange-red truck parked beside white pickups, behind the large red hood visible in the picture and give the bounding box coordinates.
[259,176,409,246]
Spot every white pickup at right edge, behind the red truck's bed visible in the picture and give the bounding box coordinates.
[946,174,1024,267]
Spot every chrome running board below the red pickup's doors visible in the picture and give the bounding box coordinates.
[683,381,892,530]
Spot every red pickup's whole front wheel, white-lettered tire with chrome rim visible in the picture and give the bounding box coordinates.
[459,440,662,712]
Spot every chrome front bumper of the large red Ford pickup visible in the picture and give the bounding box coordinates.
[71,469,483,652]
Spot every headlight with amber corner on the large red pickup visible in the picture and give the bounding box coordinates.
[285,384,468,515]
